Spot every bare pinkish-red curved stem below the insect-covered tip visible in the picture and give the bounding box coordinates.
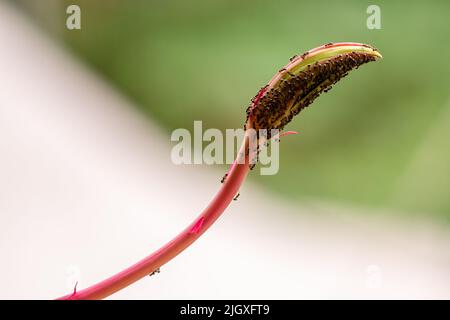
[59,135,250,300]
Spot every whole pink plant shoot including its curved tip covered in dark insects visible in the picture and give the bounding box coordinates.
[55,42,381,300]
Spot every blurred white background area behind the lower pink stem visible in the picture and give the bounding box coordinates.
[0,2,450,299]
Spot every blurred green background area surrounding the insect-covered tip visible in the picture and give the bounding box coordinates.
[16,0,450,222]
